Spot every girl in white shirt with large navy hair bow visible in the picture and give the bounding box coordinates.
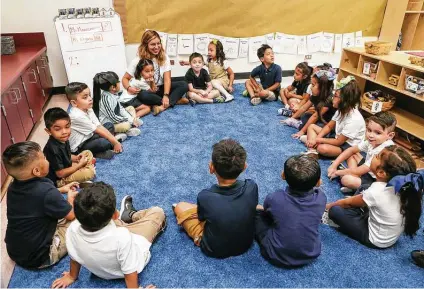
[326,145,424,248]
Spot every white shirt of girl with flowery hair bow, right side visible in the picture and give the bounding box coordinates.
[332,108,365,146]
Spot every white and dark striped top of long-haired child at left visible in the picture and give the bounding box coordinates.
[99,91,134,124]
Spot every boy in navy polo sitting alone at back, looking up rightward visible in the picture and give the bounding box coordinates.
[243,44,282,105]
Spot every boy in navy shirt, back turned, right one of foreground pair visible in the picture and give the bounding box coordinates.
[255,155,327,267]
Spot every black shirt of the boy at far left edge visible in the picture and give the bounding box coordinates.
[4,178,72,268]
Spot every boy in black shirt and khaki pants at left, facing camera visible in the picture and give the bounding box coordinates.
[43,107,96,187]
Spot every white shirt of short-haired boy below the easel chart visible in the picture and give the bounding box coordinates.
[69,107,101,152]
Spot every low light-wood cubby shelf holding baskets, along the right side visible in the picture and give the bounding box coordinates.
[338,48,424,140]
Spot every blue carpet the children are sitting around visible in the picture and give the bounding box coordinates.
[9,84,424,288]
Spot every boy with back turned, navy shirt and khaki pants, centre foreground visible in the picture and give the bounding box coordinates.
[173,139,258,258]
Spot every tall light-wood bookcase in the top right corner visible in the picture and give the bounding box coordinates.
[379,0,424,50]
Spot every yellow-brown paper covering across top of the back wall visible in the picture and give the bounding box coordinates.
[114,0,387,43]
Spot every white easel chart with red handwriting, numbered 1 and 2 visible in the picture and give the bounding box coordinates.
[55,14,127,90]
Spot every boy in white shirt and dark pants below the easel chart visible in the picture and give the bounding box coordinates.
[65,82,122,159]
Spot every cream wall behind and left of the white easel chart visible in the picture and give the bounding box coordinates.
[1,0,112,86]
